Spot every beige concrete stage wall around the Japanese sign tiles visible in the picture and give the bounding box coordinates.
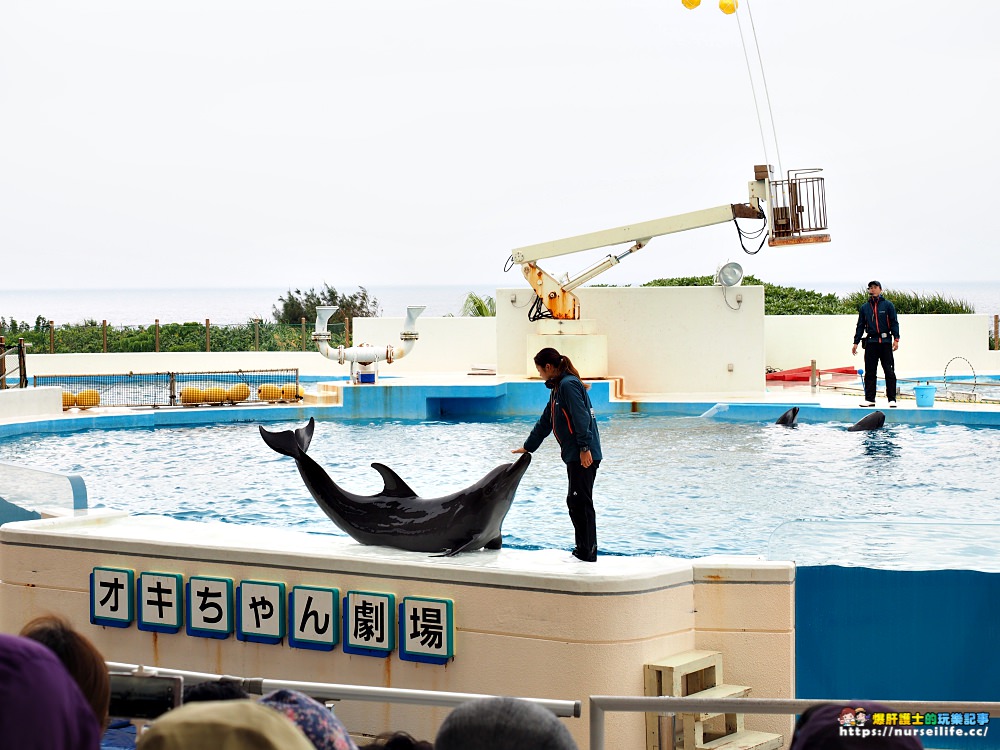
[0,511,795,748]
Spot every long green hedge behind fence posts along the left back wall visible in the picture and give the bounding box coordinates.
[0,319,348,354]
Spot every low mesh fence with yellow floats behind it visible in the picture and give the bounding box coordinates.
[33,368,303,410]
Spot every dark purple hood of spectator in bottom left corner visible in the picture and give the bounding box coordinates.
[0,634,101,750]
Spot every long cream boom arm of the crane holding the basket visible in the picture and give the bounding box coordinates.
[512,203,744,264]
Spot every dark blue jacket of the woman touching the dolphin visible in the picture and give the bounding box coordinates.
[524,373,602,464]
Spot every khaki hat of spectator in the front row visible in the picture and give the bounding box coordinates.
[136,700,313,750]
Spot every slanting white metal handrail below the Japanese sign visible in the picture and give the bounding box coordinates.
[106,661,583,718]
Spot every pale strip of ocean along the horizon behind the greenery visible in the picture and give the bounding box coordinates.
[0,279,1000,326]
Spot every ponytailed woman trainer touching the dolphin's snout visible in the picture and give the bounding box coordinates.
[511,347,602,562]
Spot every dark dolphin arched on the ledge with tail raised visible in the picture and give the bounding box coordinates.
[260,417,531,557]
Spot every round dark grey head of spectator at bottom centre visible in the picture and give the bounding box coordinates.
[434,698,577,750]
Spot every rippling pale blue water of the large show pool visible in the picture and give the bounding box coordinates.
[0,415,1000,564]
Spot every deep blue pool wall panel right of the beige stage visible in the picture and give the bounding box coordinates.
[795,566,1000,750]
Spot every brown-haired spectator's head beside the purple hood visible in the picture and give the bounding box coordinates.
[21,615,111,730]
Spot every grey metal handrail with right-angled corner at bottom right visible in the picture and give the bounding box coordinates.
[590,695,1000,750]
